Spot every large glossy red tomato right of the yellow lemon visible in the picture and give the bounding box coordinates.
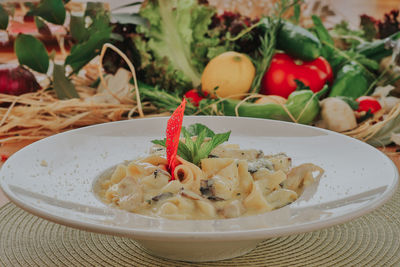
[260,53,333,98]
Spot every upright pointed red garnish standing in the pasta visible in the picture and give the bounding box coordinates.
[165,98,186,180]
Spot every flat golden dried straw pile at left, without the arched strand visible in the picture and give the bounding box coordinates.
[0,86,160,143]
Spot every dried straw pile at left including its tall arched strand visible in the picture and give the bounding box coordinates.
[0,44,175,144]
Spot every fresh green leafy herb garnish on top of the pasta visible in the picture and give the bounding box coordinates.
[151,123,231,165]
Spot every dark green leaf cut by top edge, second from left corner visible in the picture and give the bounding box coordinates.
[29,0,66,25]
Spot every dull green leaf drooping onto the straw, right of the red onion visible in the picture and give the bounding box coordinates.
[53,64,79,99]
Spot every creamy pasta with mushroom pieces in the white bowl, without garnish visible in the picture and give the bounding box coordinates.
[97,141,324,219]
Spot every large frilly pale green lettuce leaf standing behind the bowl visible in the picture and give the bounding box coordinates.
[133,0,219,90]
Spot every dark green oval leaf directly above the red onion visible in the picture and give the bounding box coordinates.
[14,34,49,73]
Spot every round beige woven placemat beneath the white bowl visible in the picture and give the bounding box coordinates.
[0,186,400,266]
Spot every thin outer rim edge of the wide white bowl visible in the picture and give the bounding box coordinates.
[0,116,399,241]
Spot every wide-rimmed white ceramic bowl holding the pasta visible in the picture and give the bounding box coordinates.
[0,117,398,261]
